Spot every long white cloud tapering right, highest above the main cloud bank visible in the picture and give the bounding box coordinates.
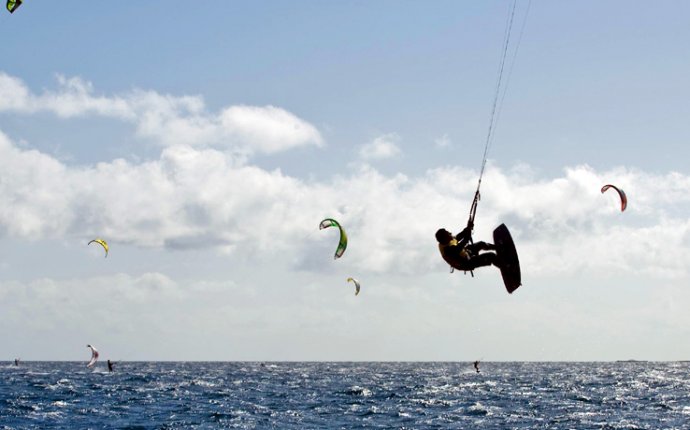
[0,73,323,154]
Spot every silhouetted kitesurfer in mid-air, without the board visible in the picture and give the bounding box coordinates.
[436,221,501,271]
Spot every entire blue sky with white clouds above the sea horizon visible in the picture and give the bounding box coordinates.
[0,0,690,361]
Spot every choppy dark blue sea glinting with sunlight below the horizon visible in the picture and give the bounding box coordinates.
[0,362,690,429]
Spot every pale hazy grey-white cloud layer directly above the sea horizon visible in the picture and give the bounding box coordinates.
[5,266,690,360]
